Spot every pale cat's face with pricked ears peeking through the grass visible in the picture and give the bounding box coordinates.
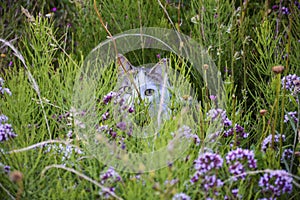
[117,54,170,116]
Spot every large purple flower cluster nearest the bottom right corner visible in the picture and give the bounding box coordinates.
[259,170,293,197]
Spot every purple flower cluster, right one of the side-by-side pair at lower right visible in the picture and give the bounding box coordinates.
[226,148,257,180]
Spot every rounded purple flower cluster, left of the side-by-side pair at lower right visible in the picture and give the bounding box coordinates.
[194,152,223,174]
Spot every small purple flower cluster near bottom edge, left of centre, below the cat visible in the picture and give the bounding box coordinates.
[99,167,122,199]
